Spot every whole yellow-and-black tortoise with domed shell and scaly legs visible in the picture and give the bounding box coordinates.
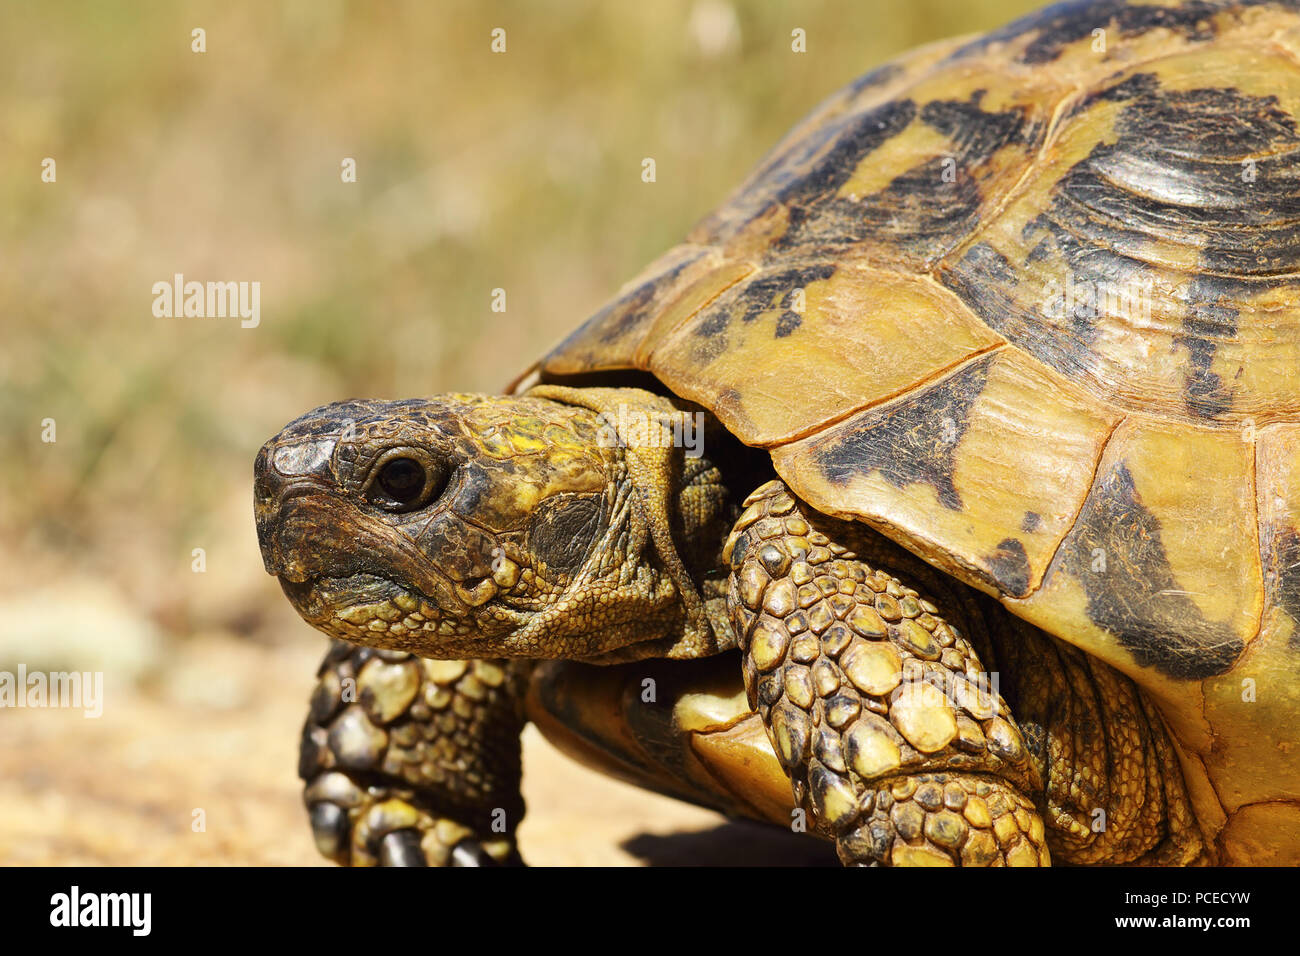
[255,0,1300,866]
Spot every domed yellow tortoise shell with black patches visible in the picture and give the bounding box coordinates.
[522,0,1300,858]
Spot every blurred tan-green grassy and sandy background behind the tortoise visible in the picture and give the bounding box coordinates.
[0,0,1039,864]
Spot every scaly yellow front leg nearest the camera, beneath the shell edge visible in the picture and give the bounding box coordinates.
[724,481,1048,866]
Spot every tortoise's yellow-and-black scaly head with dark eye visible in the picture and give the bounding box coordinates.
[255,385,722,658]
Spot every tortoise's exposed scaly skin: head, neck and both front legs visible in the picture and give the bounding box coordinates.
[256,386,1203,865]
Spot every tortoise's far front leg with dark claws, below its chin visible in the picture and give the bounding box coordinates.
[299,640,524,866]
